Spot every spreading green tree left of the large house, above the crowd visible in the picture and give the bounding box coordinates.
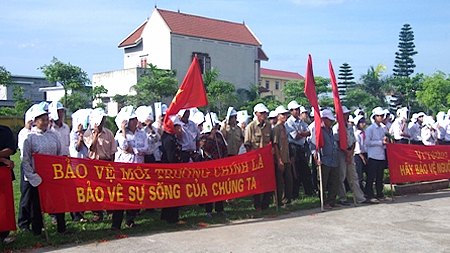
[38,57,91,109]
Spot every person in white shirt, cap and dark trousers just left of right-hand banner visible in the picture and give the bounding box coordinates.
[365,108,388,200]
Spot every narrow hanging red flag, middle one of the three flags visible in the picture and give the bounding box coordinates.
[305,55,324,151]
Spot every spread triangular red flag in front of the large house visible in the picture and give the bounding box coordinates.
[164,55,208,134]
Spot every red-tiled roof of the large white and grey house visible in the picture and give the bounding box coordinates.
[119,9,261,48]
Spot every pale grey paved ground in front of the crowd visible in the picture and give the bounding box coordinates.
[34,189,450,253]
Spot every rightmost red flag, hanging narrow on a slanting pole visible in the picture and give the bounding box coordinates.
[328,60,347,150]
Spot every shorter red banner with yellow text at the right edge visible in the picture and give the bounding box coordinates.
[387,144,450,183]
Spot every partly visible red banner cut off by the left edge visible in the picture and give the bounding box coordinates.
[0,166,16,232]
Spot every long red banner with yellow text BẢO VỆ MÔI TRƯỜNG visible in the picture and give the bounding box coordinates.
[34,145,276,213]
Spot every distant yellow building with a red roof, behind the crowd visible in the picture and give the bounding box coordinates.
[259,68,305,102]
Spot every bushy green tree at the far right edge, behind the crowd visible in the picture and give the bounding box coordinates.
[417,71,450,113]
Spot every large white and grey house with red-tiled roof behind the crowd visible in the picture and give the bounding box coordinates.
[93,8,268,114]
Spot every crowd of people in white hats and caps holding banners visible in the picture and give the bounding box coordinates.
[0,101,450,241]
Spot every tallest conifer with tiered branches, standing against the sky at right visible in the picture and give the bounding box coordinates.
[393,24,417,77]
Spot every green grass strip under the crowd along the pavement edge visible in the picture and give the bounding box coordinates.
[0,152,390,252]
